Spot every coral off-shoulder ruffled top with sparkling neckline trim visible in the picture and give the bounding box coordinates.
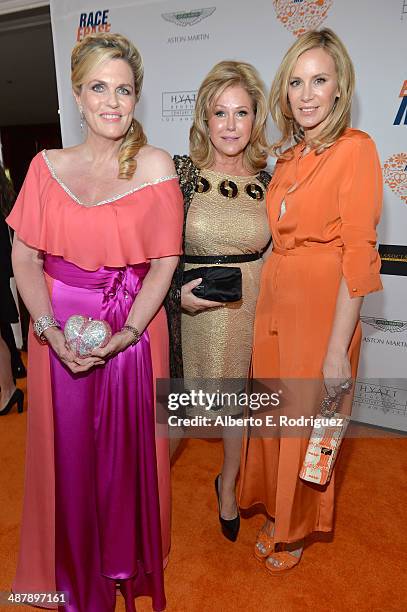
[7,151,183,270]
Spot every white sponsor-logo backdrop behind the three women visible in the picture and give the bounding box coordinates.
[51,0,407,431]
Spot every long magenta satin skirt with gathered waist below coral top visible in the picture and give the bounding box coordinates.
[44,255,166,612]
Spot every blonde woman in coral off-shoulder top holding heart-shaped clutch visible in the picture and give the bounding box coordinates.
[8,34,183,612]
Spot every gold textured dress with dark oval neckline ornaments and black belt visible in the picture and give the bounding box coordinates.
[181,170,270,412]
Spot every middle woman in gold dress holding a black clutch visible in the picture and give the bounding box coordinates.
[168,61,270,541]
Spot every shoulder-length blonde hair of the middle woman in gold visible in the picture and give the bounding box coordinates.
[189,60,269,173]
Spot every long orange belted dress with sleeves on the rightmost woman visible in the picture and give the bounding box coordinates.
[239,129,382,542]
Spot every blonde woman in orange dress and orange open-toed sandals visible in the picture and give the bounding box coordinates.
[240,29,382,574]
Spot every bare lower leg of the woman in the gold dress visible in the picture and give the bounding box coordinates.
[220,427,242,519]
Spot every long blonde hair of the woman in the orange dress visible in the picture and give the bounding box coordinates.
[269,28,355,159]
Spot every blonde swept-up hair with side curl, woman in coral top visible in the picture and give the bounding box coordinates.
[71,33,147,179]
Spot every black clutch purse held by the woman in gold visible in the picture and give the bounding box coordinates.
[182,266,242,302]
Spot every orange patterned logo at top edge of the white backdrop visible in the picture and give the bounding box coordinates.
[273,0,333,36]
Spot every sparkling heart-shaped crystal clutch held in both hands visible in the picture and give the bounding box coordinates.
[64,315,112,357]
